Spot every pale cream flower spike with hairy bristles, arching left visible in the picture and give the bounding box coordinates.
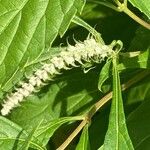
[1,38,113,115]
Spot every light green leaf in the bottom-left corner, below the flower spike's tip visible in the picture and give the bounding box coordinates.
[0,116,44,150]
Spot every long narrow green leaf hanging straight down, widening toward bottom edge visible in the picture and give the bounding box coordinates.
[104,58,134,150]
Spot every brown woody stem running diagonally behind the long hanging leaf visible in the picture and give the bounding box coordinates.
[57,70,150,150]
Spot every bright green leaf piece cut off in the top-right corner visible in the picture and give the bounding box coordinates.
[129,0,150,19]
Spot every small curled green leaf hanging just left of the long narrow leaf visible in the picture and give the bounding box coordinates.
[98,60,112,91]
